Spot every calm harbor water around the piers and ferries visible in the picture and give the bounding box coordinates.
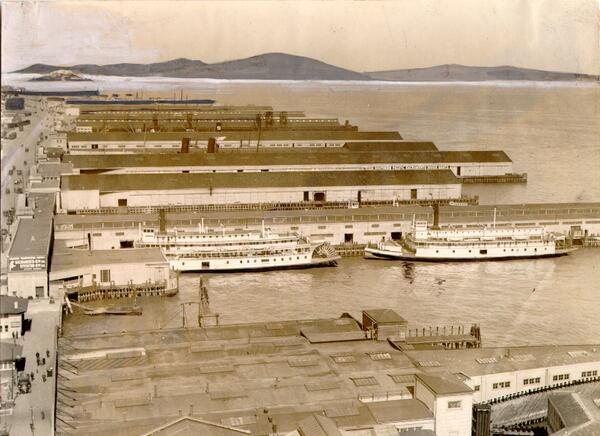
[15,79,600,345]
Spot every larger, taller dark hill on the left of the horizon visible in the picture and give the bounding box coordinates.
[16,53,371,80]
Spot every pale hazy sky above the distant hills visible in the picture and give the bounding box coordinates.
[2,0,600,75]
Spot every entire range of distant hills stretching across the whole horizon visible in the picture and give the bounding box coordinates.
[15,53,598,82]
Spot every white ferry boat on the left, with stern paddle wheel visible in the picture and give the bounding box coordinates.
[136,224,340,272]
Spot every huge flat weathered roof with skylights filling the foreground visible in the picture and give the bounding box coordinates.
[59,316,433,436]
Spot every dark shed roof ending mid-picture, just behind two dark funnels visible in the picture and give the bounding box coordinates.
[67,130,402,143]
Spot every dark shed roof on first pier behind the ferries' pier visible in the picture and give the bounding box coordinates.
[62,170,460,192]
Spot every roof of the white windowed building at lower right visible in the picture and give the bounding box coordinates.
[405,345,600,377]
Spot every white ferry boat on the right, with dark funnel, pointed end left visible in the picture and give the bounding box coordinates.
[364,209,575,261]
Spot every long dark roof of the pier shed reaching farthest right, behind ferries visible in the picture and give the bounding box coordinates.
[63,151,511,169]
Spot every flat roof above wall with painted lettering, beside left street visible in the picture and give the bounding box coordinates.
[8,214,52,260]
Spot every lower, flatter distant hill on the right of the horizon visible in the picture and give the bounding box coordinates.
[367,64,598,82]
